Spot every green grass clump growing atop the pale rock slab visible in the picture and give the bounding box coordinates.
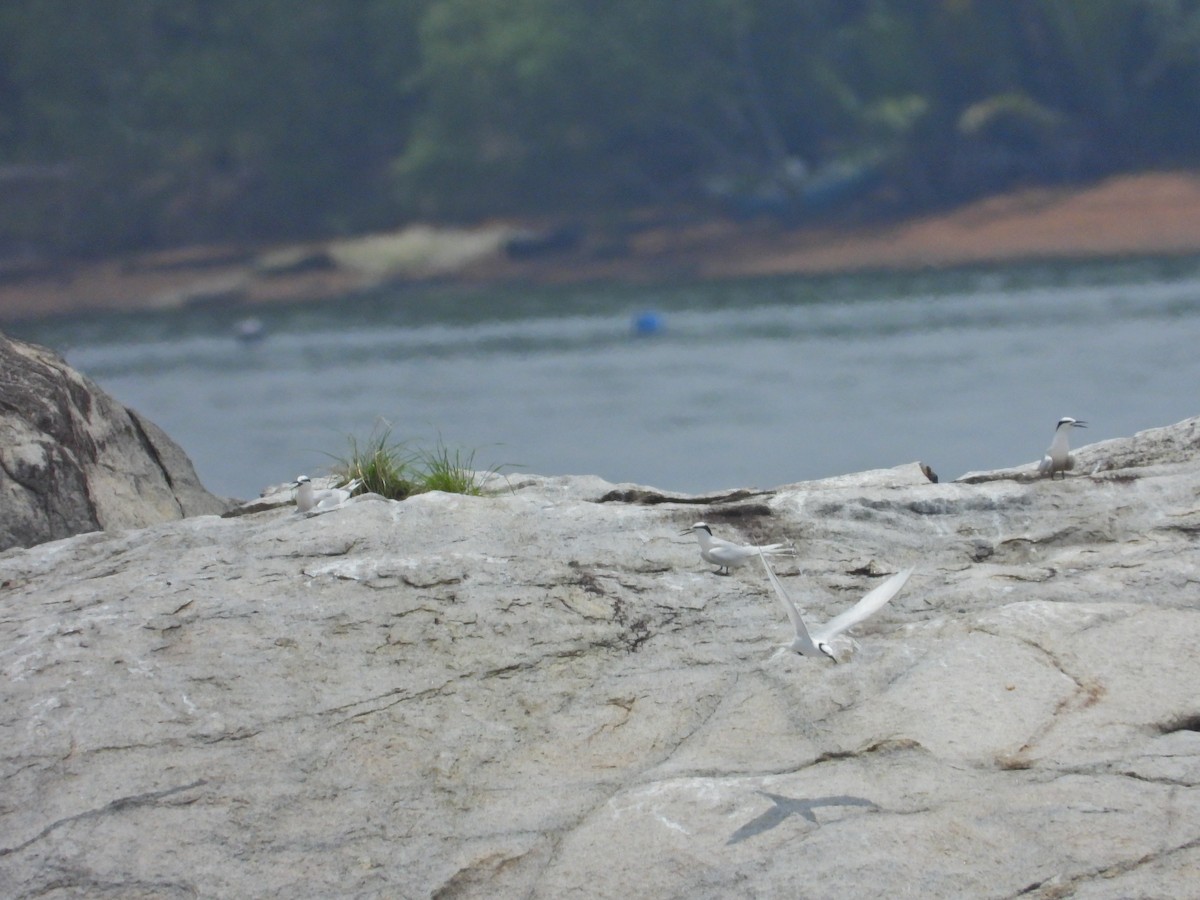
[332,426,499,500]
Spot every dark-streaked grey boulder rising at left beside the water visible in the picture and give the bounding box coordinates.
[0,335,228,550]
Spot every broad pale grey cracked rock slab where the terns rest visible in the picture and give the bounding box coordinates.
[0,419,1200,899]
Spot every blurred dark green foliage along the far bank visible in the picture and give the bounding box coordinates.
[0,0,1200,256]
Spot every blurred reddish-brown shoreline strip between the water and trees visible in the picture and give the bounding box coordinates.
[0,170,1200,323]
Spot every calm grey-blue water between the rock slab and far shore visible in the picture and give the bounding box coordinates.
[8,258,1200,497]
